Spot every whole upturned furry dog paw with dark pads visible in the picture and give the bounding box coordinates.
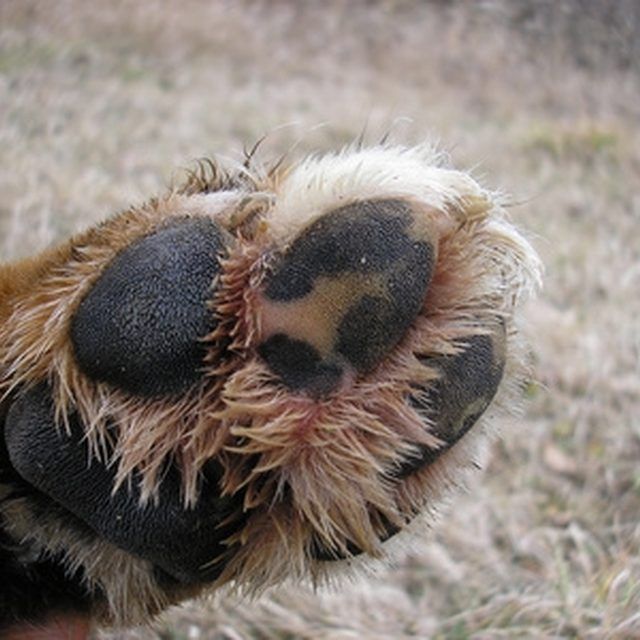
[0,148,537,625]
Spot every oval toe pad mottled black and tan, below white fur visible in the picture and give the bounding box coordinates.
[258,200,435,395]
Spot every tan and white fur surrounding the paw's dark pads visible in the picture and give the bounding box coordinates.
[0,148,538,621]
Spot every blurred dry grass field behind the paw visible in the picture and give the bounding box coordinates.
[0,0,640,640]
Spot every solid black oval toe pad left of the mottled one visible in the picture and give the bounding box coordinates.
[71,218,225,396]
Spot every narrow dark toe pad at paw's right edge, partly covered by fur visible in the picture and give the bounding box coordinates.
[397,327,506,478]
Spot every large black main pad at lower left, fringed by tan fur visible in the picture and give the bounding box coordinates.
[5,385,241,583]
